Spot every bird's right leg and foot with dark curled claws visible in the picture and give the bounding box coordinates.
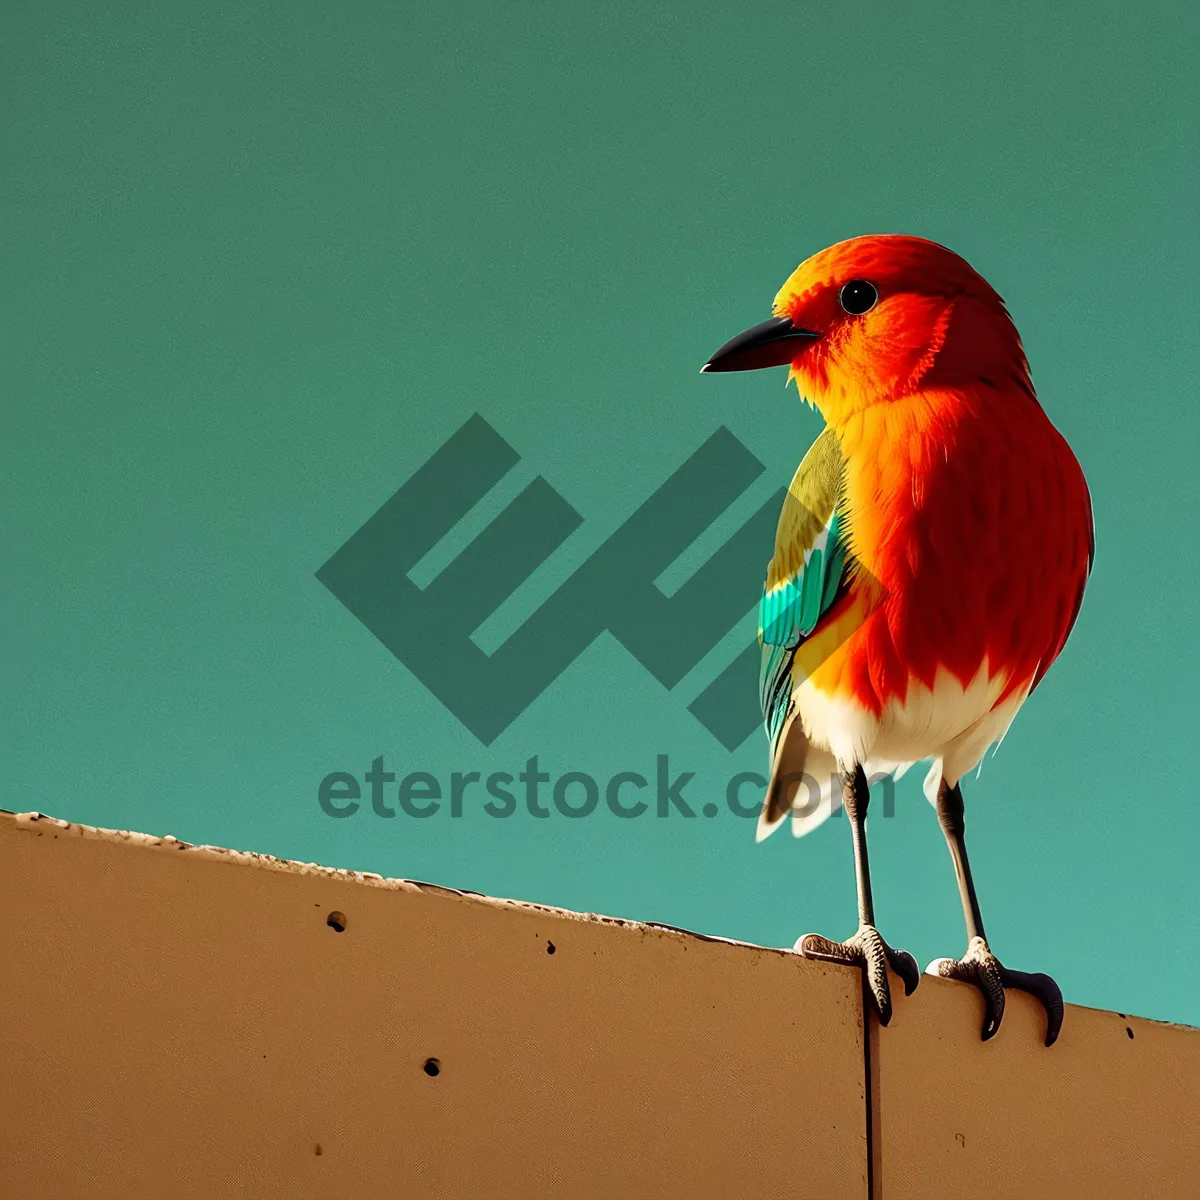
[925,779,1063,1046]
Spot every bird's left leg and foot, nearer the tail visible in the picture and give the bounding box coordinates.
[796,767,920,1025]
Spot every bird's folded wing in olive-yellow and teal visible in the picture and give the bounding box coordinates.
[758,430,848,762]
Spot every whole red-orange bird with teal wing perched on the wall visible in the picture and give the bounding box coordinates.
[701,234,1096,1046]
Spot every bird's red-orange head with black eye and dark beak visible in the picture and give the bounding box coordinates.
[702,234,1032,424]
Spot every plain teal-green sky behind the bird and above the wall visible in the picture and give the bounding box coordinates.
[0,0,1200,1022]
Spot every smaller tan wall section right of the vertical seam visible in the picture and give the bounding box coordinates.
[871,979,1200,1200]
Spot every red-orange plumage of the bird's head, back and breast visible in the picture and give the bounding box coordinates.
[775,236,1092,713]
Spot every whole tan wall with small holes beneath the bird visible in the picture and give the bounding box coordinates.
[0,815,1200,1200]
